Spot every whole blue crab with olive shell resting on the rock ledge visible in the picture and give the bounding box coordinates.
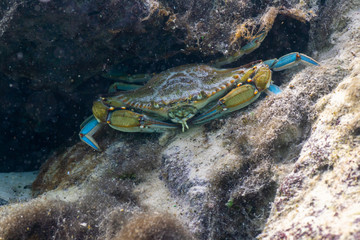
[79,34,319,151]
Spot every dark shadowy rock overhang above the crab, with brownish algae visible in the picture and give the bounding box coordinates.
[0,0,319,84]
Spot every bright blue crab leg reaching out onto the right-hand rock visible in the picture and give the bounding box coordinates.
[264,52,320,71]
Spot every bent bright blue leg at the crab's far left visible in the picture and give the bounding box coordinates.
[79,115,101,151]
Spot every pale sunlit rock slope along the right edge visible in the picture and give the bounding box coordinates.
[260,6,360,239]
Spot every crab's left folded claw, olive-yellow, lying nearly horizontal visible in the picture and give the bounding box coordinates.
[106,110,178,132]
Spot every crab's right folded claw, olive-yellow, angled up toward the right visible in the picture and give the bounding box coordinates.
[192,84,260,124]
